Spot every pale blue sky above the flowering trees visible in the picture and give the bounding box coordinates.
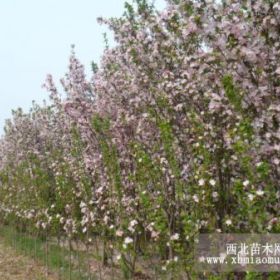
[0,0,164,134]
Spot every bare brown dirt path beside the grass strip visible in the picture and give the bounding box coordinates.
[0,238,58,280]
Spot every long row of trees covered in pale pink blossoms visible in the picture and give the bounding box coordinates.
[0,0,280,279]
